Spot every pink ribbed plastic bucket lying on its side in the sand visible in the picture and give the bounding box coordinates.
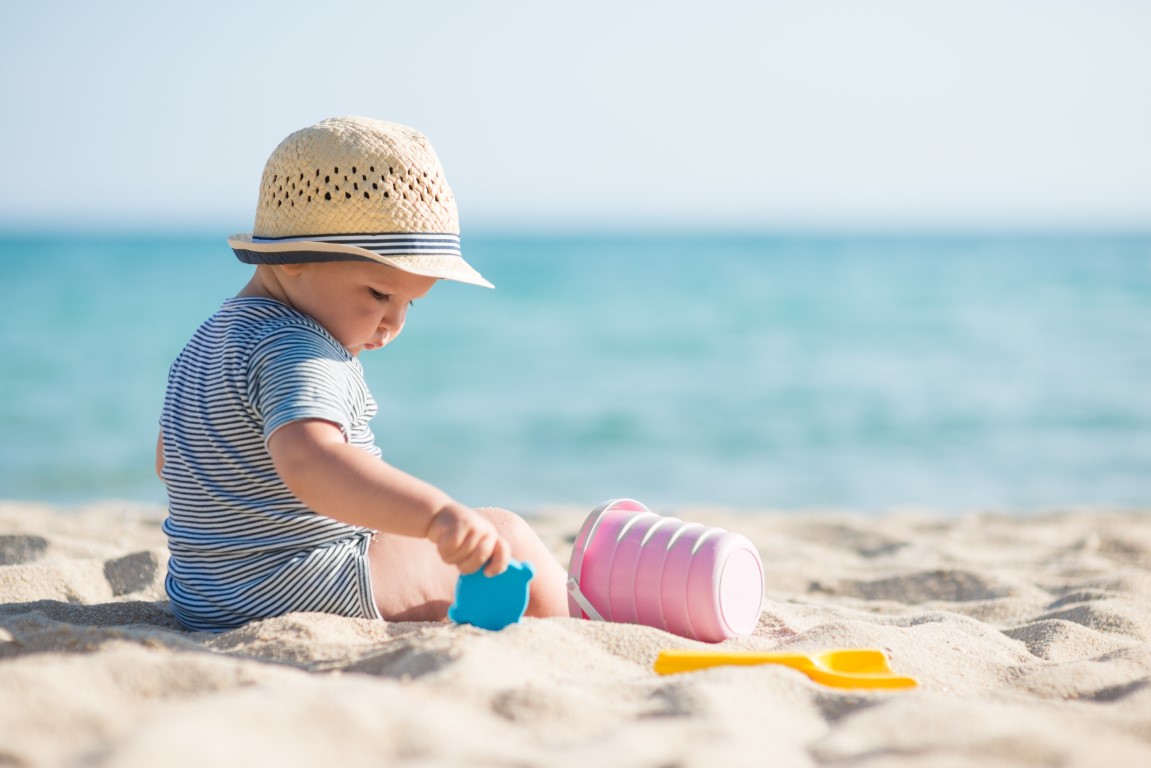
[567,499,763,642]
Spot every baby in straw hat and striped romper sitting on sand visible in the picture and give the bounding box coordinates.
[157,117,569,631]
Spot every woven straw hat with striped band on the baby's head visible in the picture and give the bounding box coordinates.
[228,117,493,288]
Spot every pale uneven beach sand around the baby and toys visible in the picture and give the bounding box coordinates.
[0,503,1151,768]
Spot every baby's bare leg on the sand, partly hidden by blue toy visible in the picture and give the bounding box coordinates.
[368,508,569,622]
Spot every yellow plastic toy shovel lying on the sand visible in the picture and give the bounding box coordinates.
[655,648,918,689]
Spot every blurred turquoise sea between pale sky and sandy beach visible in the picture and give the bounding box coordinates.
[0,231,1151,512]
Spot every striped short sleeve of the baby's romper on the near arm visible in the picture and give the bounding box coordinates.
[247,325,364,442]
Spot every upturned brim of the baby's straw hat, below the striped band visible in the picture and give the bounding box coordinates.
[228,233,495,288]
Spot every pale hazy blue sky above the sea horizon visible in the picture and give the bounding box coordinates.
[0,0,1151,231]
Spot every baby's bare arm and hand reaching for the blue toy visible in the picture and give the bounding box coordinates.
[268,419,511,576]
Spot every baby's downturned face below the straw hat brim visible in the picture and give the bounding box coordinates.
[281,261,436,355]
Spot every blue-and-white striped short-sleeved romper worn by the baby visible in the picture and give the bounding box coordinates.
[160,298,380,631]
